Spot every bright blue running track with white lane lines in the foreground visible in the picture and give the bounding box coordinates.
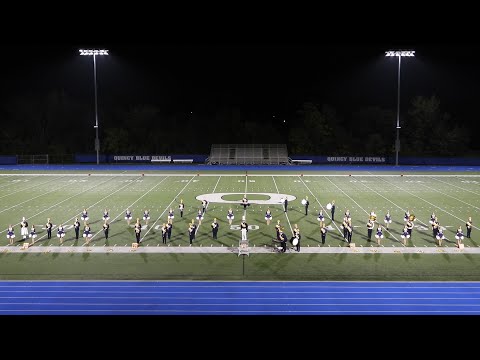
[0,281,480,315]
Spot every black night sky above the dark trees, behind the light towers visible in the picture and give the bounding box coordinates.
[0,43,480,116]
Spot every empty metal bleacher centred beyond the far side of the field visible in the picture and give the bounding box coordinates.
[206,144,291,165]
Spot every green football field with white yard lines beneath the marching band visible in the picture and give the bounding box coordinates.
[0,170,480,281]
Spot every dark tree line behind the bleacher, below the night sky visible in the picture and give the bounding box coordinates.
[0,91,472,156]
